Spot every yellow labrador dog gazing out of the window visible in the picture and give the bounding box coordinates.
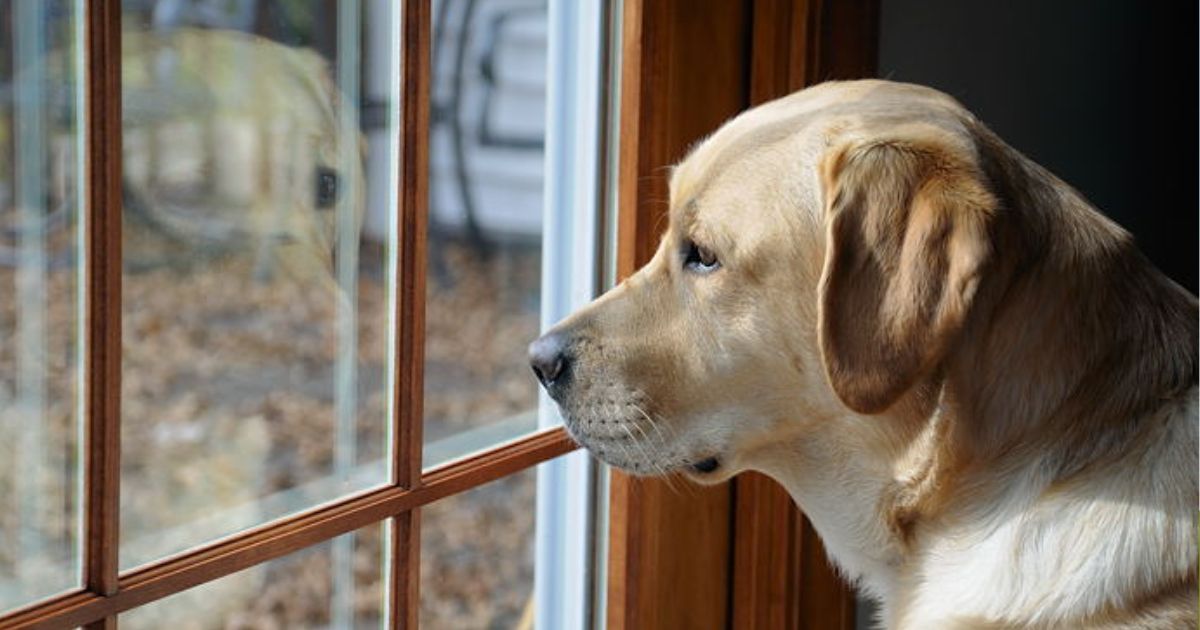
[530,80,1200,629]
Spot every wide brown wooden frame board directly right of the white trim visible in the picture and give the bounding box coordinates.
[607,0,750,630]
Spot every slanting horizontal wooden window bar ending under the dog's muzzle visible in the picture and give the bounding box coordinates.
[0,428,576,629]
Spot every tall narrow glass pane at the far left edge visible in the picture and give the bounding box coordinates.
[0,0,84,610]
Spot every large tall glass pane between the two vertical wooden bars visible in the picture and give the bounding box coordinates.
[121,0,398,566]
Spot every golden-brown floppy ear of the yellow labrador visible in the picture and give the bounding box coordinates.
[818,133,996,414]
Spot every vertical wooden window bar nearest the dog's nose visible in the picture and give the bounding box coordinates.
[386,0,432,629]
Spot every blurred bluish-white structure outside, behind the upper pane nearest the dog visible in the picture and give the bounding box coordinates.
[430,0,547,262]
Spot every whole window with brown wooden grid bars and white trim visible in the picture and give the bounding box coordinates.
[0,0,612,628]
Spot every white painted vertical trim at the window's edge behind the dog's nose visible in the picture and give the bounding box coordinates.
[534,0,607,630]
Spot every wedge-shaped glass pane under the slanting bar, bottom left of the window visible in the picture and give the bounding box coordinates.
[120,524,388,630]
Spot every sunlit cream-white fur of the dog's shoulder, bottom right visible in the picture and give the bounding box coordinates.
[896,388,1200,628]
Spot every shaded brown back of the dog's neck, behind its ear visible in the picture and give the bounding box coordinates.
[943,141,1198,476]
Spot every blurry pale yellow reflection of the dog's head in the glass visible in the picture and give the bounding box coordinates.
[122,29,364,278]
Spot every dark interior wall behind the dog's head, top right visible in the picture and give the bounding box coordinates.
[878,0,1200,293]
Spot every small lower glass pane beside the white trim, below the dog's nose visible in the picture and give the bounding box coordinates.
[420,468,536,628]
